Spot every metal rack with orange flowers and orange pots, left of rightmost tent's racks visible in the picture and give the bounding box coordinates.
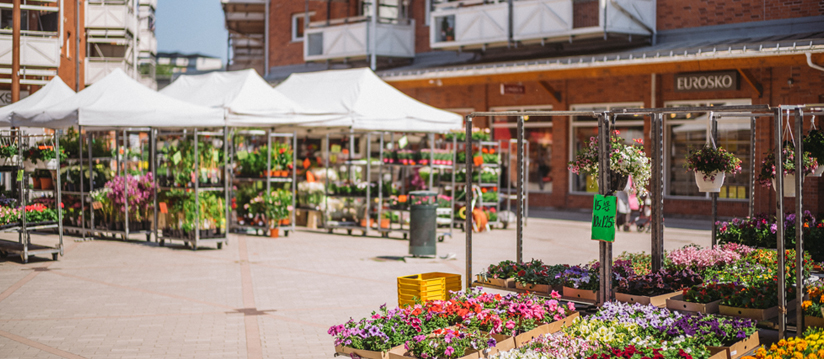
[227,130,298,237]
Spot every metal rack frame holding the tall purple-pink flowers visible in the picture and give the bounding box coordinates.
[64,126,157,242]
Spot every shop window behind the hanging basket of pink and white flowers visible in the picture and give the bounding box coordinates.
[569,103,644,194]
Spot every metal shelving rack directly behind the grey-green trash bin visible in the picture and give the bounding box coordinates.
[376,133,457,240]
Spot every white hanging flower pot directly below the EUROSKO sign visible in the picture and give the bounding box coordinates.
[685,146,741,192]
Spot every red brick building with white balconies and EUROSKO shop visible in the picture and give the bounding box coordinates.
[224,0,824,216]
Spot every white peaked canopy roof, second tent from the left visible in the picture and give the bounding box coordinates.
[11,69,225,128]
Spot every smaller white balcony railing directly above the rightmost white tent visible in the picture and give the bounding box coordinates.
[303,17,415,61]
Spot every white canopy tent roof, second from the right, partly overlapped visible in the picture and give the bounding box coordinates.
[160,69,304,126]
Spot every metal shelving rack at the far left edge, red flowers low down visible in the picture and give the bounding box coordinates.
[0,129,63,263]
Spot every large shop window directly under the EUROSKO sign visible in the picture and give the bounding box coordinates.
[664,99,752,200]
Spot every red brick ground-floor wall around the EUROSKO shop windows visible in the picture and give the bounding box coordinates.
[404,66,824,216]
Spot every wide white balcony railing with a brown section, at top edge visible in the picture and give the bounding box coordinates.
[430,0,655,49]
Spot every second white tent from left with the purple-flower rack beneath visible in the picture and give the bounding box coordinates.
[12,70,224,250]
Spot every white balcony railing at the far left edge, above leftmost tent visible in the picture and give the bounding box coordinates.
[0,30,60,67]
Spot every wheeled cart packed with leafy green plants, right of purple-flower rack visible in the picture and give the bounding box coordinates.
[152,127,230,250]
